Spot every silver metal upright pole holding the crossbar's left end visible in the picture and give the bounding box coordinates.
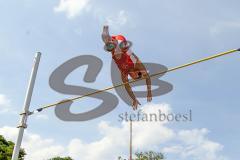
[12,52,41,160]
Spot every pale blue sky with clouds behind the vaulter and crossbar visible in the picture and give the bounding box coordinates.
[0,0,240,160]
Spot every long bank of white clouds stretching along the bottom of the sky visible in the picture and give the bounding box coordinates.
[0,104,226,160]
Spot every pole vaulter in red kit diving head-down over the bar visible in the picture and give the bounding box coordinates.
[102,26,152,110]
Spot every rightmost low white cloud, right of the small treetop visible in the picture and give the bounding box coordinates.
[163,128,227,160]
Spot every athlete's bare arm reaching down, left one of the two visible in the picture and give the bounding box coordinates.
[121,73,141,109]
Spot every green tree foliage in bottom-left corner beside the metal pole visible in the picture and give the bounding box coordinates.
[0,135,26,160]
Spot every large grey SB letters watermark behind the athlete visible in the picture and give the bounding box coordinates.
[49,55,173,121]
